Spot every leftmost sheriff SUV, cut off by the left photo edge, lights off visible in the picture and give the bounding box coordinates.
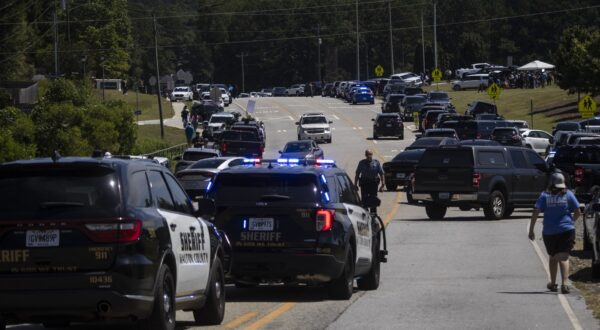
[0,155,225,330]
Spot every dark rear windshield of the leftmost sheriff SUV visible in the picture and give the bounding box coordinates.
[0,167,121,221]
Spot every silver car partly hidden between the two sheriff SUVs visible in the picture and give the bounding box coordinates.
[175,157,245,200]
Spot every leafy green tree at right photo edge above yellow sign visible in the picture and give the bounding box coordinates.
[556,26,600,95]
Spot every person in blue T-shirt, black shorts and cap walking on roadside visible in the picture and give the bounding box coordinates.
[529,173,581,294]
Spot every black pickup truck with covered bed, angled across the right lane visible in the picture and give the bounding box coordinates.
[413,146,551,220]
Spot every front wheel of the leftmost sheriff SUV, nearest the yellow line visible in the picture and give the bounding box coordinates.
[193,257,225,325]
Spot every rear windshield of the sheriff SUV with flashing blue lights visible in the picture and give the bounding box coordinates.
[211,173,320,203]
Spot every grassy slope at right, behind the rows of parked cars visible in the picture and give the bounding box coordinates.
[423,84,577,131]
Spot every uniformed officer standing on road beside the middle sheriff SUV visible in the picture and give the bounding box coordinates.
[354,149,384,209]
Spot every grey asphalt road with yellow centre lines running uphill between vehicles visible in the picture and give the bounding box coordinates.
[11,96,600,330]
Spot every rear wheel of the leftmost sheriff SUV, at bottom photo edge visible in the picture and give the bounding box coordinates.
[140,265,175,330]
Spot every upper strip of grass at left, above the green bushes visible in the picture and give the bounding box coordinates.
[93,89,174,121]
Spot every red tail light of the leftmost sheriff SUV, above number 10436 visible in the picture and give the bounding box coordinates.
[85,220,142,243]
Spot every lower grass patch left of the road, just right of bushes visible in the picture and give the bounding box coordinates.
[134,125,186,154]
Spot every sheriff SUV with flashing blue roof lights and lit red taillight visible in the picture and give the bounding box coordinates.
[199,159,387,299]
